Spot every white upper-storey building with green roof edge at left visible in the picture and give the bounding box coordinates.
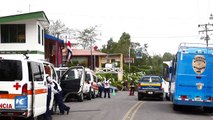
[0,11,49,59]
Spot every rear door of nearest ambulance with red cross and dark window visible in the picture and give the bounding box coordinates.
[0,59,23,116]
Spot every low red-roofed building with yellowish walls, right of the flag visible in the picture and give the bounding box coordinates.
[72,49,123,80]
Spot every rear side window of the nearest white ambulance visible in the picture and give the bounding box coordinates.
[28,62,44,81]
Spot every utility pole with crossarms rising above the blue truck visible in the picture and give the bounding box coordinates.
[198,23,213,47]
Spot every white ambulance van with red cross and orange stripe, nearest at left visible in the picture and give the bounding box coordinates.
[0,57,58,120]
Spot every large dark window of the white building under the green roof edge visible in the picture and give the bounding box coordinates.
[1,24,26,43]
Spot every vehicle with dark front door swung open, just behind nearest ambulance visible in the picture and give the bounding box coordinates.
[60,66,92,102]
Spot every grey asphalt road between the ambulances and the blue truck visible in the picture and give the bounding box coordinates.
[52,91,213,120]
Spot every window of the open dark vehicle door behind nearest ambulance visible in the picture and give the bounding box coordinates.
[61,68,82,80]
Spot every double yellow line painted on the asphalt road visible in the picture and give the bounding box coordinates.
[122,101,144,120]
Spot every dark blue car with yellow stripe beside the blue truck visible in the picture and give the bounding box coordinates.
[138,75,164,100]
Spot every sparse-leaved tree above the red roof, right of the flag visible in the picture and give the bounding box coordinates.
[75,26,100,49]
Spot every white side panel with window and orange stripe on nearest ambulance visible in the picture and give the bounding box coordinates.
[28,61,47,117]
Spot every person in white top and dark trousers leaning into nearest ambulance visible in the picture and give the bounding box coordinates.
[47,77,70,115]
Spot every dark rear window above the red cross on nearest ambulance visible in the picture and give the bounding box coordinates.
[0,60,22,81]
